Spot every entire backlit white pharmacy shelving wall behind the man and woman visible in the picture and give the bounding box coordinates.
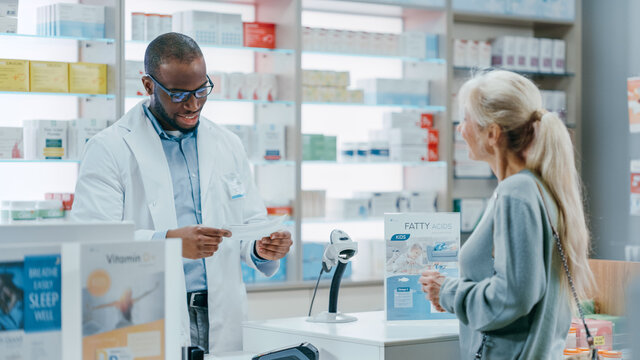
[0,0,582,291]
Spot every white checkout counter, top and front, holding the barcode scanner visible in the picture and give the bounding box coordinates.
[205,311,460,360]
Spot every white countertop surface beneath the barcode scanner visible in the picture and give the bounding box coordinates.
[243,311,459,346]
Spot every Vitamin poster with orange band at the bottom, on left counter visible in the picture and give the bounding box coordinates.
[81,243,165,360]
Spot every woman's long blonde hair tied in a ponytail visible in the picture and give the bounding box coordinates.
[459,70,594,298]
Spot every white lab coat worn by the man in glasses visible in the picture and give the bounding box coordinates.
[72,100,279,352]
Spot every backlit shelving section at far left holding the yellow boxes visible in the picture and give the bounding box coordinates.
[0,0,122,200]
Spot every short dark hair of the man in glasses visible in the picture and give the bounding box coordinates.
[144,32,202,76]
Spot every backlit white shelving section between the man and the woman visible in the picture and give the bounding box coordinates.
[297,0,448,285]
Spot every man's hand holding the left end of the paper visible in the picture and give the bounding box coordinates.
[167,225,231,259]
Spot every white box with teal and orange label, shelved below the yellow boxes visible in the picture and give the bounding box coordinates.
[23,120,68,160]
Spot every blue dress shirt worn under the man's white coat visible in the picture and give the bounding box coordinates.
[143,106,269,292]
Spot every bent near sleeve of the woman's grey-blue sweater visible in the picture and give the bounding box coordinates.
[440,196,546,331]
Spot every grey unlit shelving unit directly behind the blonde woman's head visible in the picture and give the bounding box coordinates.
[448,0,582,233]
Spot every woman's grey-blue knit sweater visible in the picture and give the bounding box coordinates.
[440,170,571,360]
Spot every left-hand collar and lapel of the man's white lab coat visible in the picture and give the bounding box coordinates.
[118,100,178,231]
